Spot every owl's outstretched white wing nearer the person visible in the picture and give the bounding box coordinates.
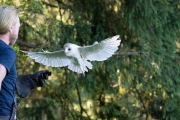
[21,50,71,67]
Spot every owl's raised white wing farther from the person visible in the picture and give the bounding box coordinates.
[79,35,121,61]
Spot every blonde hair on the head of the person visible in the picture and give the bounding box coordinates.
[0,5,19,34]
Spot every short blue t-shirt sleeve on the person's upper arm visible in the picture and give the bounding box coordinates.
[0,47,16,72]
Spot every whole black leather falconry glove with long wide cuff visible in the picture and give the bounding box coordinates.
[15,70,51,98]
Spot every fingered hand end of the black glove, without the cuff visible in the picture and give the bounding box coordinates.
[30,70,51,87]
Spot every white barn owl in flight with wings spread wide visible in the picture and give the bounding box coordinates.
[22,35,121,76]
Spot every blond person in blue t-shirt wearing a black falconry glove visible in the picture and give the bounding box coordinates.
[0,5,51,120]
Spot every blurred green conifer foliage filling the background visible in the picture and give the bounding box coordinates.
[1,0,180,120]
